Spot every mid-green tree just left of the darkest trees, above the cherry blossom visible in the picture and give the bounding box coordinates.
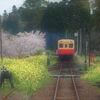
[20,0,47,31]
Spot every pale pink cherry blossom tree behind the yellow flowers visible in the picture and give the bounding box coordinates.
[2,31,46,58]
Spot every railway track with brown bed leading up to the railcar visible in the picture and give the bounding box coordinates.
[28,62,100,100]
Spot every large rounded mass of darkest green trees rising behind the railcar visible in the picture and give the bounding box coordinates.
[41,0,90,49]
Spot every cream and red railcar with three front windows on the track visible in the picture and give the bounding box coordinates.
[58,39,75,60]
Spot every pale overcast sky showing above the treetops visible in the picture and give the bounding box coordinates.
[0,0,61,15]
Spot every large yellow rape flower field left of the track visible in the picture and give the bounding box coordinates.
[0,55,50,94]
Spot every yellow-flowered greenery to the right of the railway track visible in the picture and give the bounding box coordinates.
[74,55,100,84]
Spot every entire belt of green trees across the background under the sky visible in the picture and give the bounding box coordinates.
[2,0,100,50]
